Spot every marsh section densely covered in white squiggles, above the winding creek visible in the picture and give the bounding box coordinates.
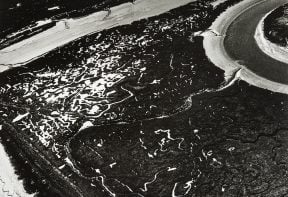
[1,2,222,195]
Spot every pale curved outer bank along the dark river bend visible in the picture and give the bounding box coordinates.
[203,0,288,94]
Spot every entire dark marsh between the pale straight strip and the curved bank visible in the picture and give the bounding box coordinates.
[0,1,288,197]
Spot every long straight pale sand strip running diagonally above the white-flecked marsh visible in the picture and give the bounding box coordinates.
[0,0,195,68]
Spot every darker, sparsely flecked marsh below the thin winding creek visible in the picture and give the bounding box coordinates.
[69,79,288,196]
